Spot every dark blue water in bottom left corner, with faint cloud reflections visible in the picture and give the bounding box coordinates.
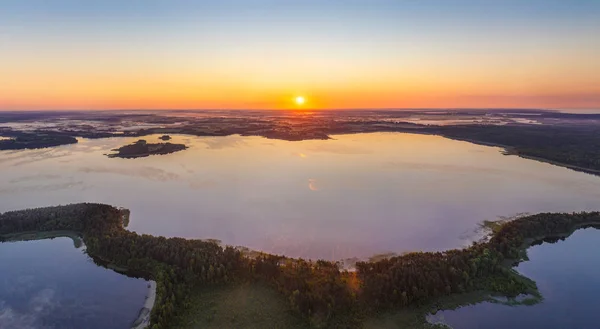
[0,238,148,329]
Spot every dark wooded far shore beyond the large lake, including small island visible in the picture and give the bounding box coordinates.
[0,112,600,174]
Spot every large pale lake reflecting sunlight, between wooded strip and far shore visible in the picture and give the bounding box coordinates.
[0,133,600,260]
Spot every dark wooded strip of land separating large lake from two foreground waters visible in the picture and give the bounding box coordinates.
[0,203,600,329]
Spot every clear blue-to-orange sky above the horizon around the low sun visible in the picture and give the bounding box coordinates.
[0,0,600,110]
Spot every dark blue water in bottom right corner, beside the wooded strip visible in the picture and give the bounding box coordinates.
[428,228,600,329]
